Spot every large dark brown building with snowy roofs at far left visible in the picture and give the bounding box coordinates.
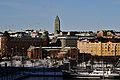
[0,31,49,56]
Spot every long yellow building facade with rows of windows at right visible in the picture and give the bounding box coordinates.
[77,40,120,56]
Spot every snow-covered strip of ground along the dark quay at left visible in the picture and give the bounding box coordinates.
[0,59,62,67]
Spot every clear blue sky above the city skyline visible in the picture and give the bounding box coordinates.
[0,0,120,32]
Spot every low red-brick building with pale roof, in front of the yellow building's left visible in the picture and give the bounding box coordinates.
[27,46,79,60]
